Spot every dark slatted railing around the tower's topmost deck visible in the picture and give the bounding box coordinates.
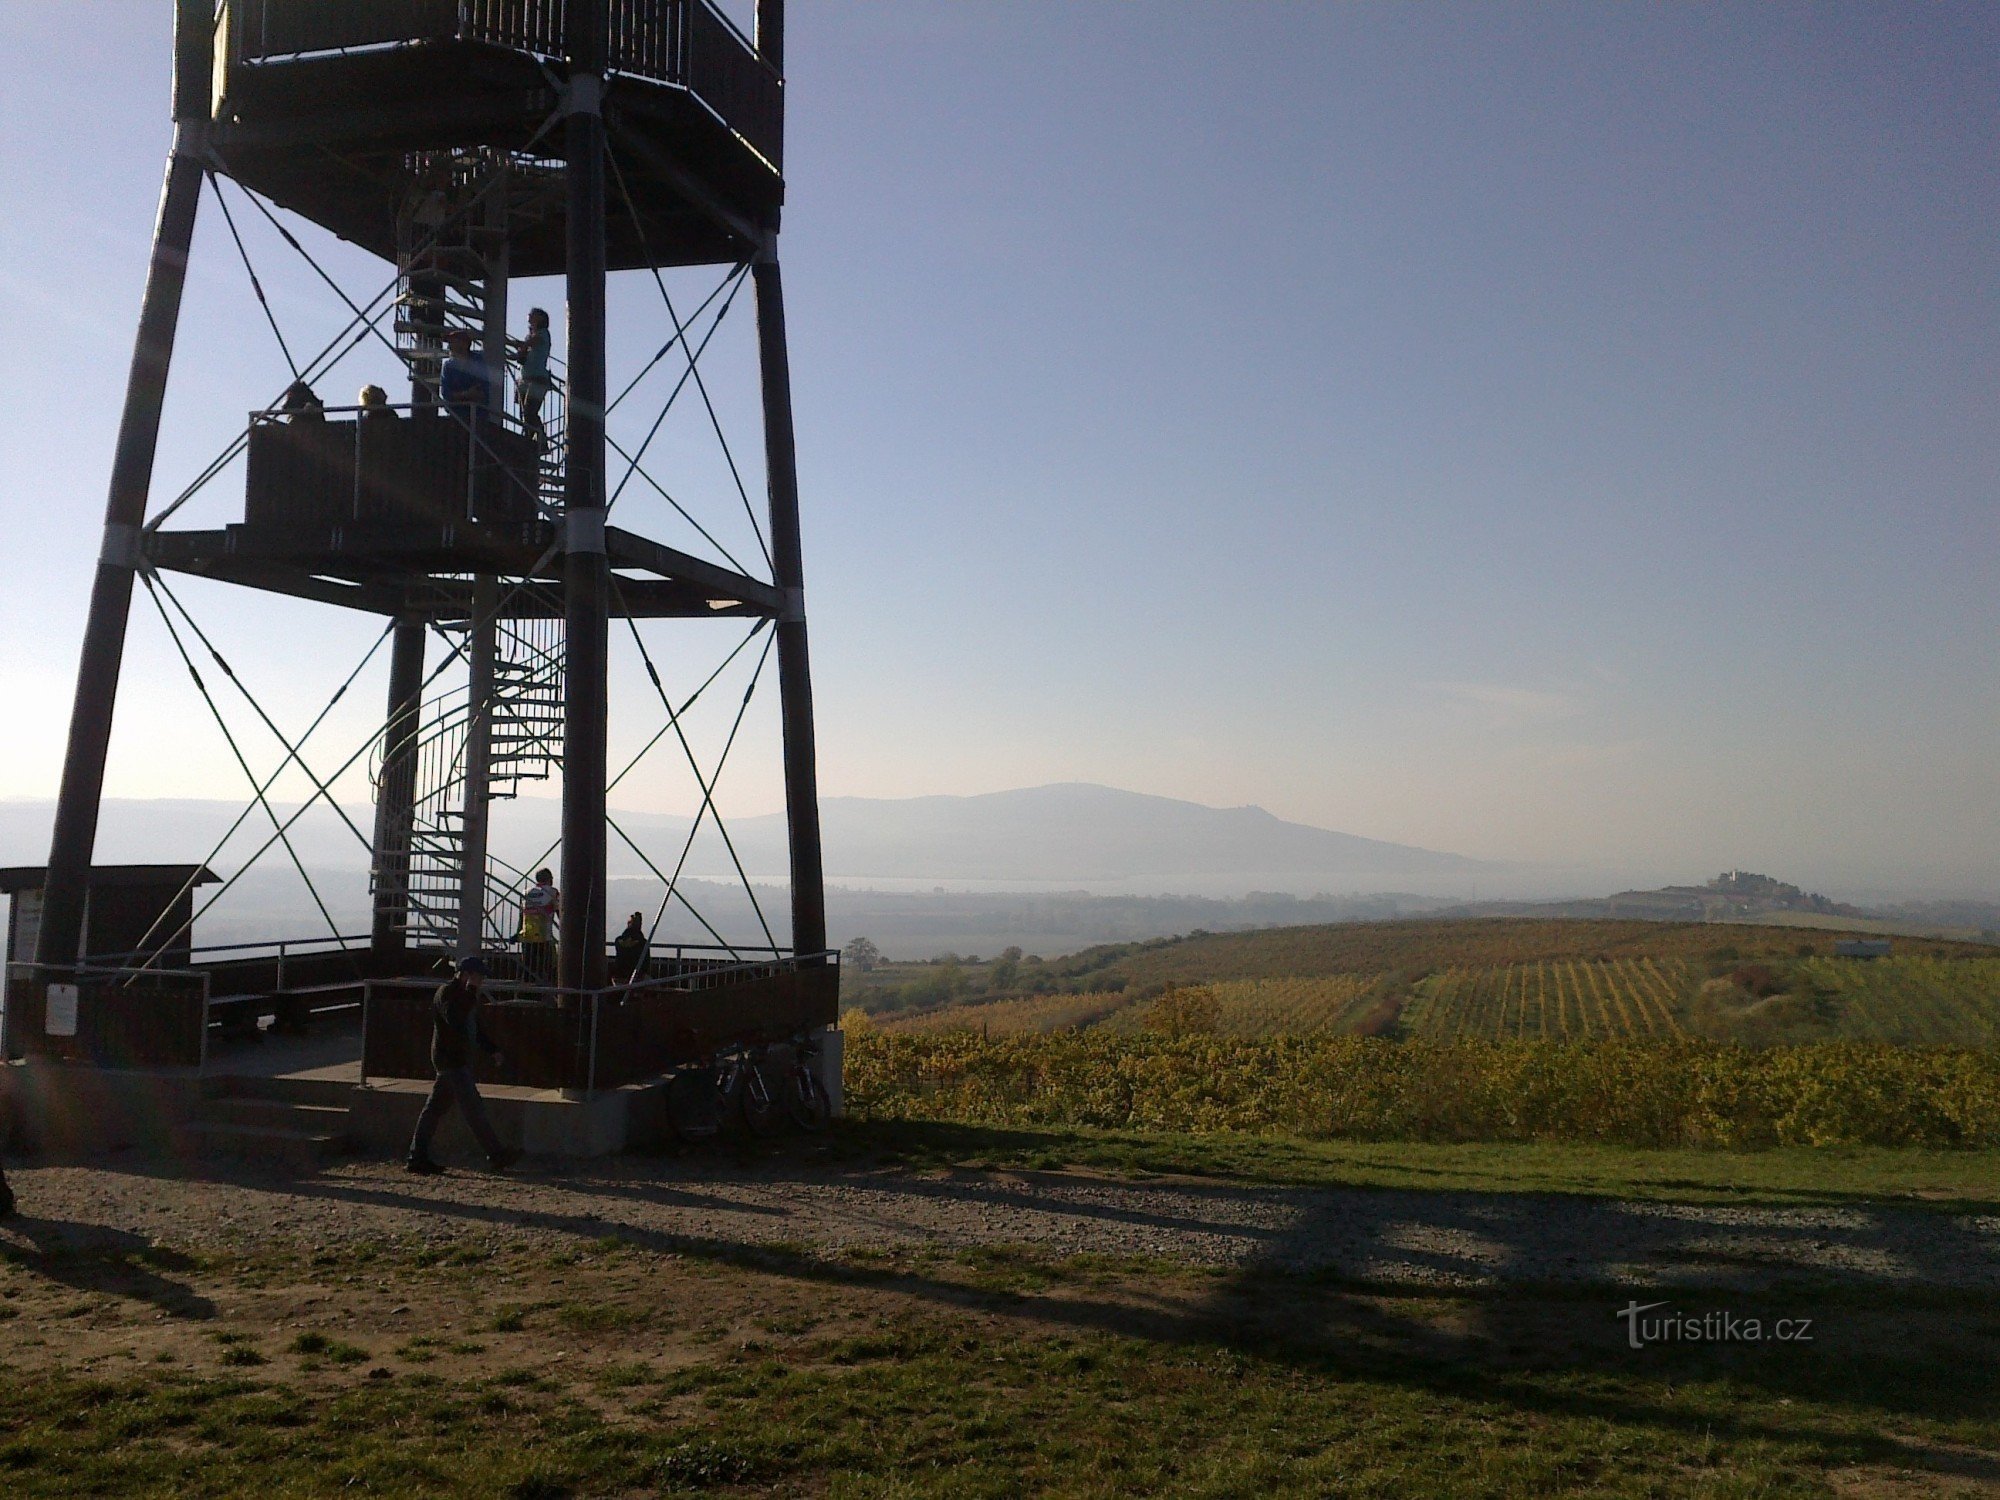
[224,0,784,168]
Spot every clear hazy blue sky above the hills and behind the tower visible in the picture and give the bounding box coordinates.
[0,0,2000,896]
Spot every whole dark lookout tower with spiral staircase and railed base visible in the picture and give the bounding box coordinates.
[8,0,838,1086]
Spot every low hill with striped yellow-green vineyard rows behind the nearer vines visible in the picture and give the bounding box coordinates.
[848,918,2000,1046]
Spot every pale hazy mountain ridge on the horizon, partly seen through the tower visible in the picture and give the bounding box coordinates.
[0,782,1498,894]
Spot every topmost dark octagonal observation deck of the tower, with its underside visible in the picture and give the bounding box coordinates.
[210,0,784,276]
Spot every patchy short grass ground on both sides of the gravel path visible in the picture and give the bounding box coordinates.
[0,1128,2000,1500]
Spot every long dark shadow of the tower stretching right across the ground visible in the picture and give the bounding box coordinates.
[0,1156,2000,1478]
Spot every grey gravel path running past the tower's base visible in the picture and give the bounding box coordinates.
[0,1156,2000,1286]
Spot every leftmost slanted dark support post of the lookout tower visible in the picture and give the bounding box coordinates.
[36,114,208,964]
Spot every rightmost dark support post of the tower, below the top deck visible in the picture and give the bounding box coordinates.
[750,258,826,954]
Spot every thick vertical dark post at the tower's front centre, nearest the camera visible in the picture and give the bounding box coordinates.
[556,17,610,988]
